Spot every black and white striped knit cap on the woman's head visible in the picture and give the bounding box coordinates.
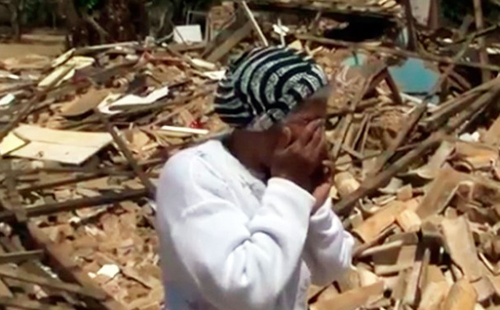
[214,47,328,131]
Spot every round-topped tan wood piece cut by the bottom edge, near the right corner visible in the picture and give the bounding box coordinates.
[442,279,477,310]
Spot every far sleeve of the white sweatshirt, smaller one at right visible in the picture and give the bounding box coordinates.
[304,199,354,285]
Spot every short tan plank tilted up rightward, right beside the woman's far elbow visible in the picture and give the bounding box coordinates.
[353,201,405,242]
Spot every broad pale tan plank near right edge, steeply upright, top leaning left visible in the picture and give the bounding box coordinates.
[441,216,483,281]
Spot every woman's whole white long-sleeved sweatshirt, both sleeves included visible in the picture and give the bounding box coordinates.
[157,140,354,310]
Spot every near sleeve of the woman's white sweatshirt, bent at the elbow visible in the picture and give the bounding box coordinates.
[157,154,315,310]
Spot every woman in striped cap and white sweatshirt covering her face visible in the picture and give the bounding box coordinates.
[157,47,354,310]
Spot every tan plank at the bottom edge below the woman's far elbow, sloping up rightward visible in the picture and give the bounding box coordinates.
[315,281,384,310]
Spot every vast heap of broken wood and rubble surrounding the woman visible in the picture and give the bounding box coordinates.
[0,0,500,310]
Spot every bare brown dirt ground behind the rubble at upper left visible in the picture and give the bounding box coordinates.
[0,29,64,59]
